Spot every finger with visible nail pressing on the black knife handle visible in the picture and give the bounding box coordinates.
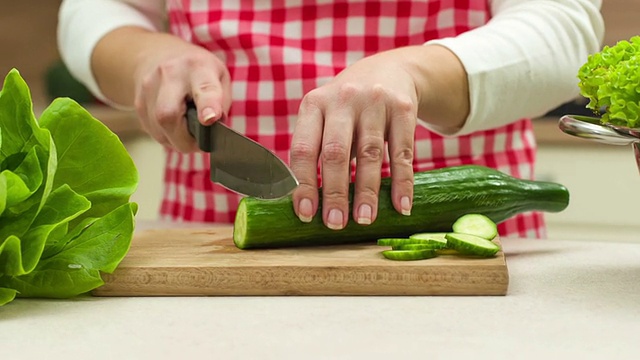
[190,66,228,125]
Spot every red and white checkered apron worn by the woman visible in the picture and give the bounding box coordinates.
[161,0,546,237]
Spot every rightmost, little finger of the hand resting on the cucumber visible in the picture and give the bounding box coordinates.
[389,96,416,216]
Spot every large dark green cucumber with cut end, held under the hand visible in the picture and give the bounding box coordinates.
[233,165,569,249]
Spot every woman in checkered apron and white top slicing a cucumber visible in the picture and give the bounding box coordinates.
[59,0,603,237]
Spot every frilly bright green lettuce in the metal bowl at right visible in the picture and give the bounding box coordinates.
[578,36,640,127]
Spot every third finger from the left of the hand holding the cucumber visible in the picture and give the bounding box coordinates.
[353,102,386,225]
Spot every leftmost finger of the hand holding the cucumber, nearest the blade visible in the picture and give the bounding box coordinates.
[290,97,324,223]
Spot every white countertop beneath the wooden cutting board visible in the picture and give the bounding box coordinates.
[0,233,640,360]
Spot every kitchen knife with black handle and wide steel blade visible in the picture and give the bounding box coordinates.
[182,101,298,199]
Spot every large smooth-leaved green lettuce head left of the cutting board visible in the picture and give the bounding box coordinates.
[0,69,138,305]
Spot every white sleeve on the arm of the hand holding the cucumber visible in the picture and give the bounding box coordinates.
[427,0,604,135]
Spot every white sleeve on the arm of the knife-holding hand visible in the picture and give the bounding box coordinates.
[57,0,164,103]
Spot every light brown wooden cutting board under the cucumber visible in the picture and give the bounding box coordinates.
[93,226,509,296]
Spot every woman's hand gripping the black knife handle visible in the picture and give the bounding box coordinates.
[133,37,231,152]
